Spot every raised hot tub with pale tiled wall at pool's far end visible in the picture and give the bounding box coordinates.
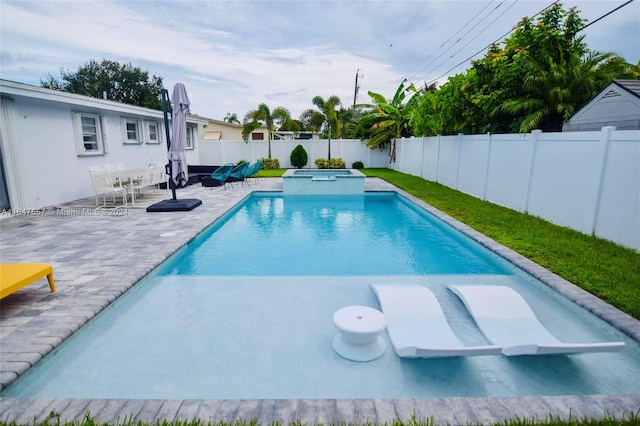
[282,169,365,195]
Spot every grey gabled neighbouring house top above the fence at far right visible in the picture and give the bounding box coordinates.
[562,80,640,132]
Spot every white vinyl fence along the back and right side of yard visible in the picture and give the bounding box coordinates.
[200,127,640,251]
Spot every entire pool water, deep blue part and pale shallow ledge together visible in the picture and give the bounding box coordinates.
[2,194,640,399]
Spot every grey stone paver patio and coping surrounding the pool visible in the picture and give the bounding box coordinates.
[0,178,640,425]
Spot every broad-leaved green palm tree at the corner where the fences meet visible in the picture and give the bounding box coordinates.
[362,79,416,163]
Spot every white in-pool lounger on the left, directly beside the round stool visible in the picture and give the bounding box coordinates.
[371,285,502,358]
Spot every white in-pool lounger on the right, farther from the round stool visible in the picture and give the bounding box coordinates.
[448,285,624,356]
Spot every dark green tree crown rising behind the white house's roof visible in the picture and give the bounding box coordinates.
[40,59,162,109]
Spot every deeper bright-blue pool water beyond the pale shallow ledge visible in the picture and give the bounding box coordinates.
[159,193,512,276]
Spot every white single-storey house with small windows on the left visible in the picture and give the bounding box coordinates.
[0,80,205,210]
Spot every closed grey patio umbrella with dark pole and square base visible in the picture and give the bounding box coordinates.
[147,83,202,212]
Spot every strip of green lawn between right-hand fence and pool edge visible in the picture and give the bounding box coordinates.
[361,169,640,319]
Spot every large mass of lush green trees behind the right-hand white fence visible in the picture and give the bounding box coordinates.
[411,3,638,136]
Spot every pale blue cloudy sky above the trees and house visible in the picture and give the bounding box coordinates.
[0,0,640,119]
